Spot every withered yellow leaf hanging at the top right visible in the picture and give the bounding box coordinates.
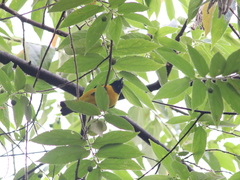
[202,2,216,36]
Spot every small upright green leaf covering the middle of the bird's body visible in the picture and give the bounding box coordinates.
[95,86,109,111]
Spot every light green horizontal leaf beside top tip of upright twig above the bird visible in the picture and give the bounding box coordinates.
[113,39,159,56]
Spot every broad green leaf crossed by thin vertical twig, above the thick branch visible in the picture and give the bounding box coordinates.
[57,54,104,73]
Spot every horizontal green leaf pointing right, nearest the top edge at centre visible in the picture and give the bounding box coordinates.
[118,3,148,14]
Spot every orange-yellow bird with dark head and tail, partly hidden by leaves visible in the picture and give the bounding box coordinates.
[60,78,123,116]
